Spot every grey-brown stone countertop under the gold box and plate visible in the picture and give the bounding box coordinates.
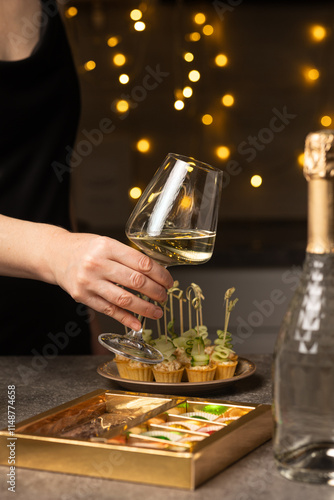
[0,354,334,500]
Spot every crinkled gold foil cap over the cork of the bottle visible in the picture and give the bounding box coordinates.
[304,130,334,180]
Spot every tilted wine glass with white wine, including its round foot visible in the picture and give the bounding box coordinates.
[99,153,223,364]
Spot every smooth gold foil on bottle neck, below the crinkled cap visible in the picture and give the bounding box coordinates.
[306,178,334,254]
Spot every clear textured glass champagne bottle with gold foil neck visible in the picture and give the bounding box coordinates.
[273,130,334,485]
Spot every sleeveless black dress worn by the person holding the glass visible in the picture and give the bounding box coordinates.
[0,0,90,357]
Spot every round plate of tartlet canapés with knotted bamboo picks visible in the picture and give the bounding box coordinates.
[97,282,256,394]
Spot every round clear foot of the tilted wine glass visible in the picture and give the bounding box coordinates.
[98,333,164,364]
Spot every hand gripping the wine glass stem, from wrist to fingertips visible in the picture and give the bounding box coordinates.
[50,233,173,330]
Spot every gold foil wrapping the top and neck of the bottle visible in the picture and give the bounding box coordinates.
[304,130,334,254]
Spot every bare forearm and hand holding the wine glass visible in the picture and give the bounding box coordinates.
[0,215,173,330]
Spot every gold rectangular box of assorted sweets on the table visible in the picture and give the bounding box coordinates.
[0,389,272,489]
